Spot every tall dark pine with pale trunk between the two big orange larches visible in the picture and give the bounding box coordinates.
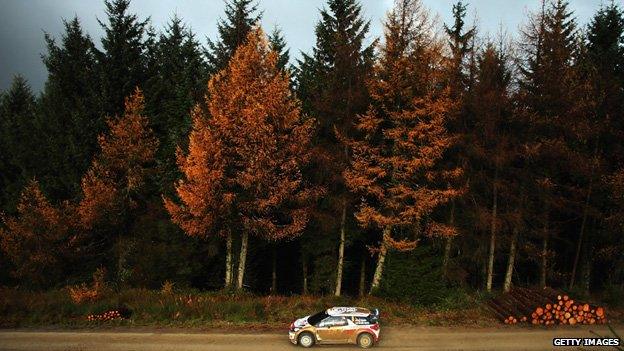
[296,0,375,295]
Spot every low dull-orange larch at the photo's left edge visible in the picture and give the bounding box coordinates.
[0,180,72,287]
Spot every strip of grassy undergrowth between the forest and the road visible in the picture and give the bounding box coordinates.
[0,284,492,328]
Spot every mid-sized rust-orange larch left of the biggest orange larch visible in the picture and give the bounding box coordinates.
[76,88,158,284]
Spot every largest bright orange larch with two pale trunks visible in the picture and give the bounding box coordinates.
[164,28,317,289]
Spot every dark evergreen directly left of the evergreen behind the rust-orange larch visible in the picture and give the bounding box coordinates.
[39,17,104,200]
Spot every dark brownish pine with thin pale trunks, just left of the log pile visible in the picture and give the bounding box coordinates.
[466,43,523,291]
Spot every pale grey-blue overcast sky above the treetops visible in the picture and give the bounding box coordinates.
[0,0,604,91]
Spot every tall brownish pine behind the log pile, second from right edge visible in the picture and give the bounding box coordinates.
[520,0,582,286]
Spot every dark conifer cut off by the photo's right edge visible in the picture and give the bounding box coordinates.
[569,2,624,291]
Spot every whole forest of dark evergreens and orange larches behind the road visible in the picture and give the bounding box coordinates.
[0,0,624,305]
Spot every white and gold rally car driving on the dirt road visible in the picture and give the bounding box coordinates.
[288,307,379,348]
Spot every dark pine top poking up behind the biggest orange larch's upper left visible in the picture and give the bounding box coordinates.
[206,0,262,74]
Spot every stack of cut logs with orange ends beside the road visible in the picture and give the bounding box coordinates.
[487,288,607,326]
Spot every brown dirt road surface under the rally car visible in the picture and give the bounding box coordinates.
[0,326,624,351]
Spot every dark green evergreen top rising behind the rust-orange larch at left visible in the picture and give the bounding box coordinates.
[98,0,149,116]
